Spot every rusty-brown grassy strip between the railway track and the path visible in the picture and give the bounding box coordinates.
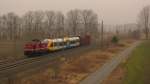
[12,41,133,84]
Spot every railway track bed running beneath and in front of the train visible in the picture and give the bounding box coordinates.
[0,46,99,80]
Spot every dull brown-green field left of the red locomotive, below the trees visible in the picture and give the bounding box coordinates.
[0,41,23,60]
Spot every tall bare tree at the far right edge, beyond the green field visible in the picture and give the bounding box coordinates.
[138,6,150,39]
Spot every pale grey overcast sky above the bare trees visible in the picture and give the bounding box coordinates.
[0,0,150,24]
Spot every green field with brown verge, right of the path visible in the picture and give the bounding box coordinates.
[103,41,150,84]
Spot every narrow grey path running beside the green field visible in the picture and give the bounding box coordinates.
[80,42,140,84]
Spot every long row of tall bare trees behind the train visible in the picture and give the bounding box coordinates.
[0,9,99,40]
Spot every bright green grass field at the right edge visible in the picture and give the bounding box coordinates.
[123,41,150,84]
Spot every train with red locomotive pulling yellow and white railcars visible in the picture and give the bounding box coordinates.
[24,35,91,56]
